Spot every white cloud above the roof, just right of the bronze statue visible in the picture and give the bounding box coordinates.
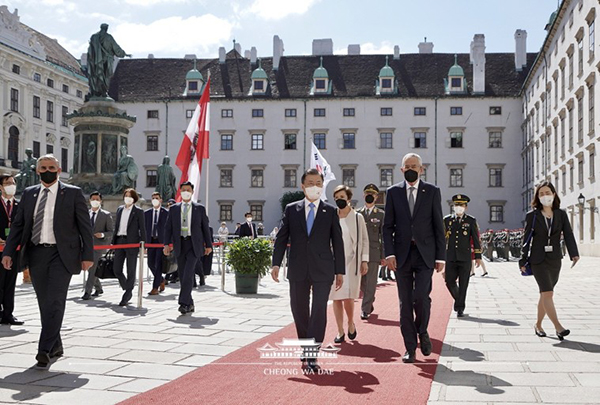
[111,14,233,57]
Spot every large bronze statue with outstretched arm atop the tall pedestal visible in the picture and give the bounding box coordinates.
[87,24,131,97]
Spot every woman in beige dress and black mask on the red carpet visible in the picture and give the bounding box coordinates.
[329,185,369,343]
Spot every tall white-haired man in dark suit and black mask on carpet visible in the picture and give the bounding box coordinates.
[383,153,446,363]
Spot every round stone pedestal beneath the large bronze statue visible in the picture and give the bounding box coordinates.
[68,98,136,197]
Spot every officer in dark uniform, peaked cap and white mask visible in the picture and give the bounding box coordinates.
[444,194,481,318]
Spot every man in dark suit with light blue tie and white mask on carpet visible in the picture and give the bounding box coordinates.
[271,169,346,372]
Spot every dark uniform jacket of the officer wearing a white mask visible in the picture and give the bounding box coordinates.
[444,214,481,262]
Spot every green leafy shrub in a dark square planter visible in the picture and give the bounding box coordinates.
[225,238,273,294]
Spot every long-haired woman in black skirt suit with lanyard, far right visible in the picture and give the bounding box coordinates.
[519,181,579,340]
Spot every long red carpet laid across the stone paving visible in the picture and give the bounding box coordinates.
[122,274,452,405]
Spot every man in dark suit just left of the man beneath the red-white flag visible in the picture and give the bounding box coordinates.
[144,191,169,295]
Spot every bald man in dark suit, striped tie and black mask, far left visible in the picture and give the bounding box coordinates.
[2,155,94,369]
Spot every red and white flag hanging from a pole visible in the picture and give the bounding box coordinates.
[175,77,210,202]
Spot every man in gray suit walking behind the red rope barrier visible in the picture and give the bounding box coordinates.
[81,191,113,301]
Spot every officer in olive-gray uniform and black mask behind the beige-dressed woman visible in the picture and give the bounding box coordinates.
[357,183,385,320]
